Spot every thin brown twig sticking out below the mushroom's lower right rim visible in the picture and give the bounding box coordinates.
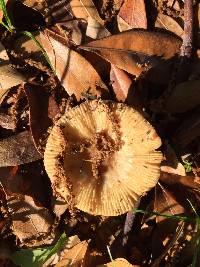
[122,199,140,247]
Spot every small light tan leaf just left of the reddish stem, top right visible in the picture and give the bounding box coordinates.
[155,13,183,37]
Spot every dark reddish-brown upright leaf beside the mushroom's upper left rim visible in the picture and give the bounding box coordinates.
[24,84,60,154]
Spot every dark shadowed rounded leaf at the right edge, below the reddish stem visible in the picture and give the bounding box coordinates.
[165,80,200,113]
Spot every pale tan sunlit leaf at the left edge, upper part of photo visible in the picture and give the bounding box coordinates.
[0,43,25,90]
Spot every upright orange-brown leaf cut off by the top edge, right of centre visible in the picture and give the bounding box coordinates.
[118,0,147,29]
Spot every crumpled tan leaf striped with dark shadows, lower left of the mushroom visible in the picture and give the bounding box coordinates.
[7,195,53,246]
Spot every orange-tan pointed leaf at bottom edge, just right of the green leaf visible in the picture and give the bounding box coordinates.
[55,241,88,267]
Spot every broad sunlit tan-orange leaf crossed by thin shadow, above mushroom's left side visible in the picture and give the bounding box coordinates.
[40,29,108,100]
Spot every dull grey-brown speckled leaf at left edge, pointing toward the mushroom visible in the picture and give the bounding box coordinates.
[0,131,42,167]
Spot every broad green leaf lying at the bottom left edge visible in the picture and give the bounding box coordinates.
[11,233,67,267]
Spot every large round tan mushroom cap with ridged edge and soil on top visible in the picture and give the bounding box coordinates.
[44,100,162,216]
